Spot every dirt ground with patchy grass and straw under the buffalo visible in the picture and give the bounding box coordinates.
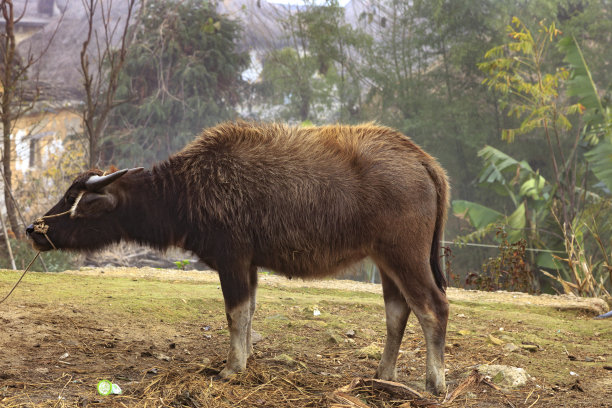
[0,268,612,408]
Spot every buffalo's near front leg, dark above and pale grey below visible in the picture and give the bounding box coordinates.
[219,264,252,378]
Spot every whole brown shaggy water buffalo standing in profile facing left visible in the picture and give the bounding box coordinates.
[27,122,449,394]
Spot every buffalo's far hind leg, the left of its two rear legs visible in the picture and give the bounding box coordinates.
[376,269,410,381]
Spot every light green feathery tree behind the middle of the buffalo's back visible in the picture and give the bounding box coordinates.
[259,0,371,122]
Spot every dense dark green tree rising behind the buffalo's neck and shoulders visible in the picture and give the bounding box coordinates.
[105,0,249,164]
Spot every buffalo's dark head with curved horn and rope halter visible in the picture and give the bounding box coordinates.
[26,168,142,251]
